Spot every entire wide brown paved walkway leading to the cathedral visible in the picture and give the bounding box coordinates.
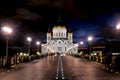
[0,56,120,80]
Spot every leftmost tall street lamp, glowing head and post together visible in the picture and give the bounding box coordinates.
[2,26,12,66]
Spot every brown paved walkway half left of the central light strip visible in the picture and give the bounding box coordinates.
[0,56,57,80]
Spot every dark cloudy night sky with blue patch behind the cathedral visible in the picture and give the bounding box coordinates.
[0,0,120,52]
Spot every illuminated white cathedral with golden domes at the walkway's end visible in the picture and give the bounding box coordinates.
[41,20,78,56]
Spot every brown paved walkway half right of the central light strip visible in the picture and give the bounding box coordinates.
[62,56,120,80]
